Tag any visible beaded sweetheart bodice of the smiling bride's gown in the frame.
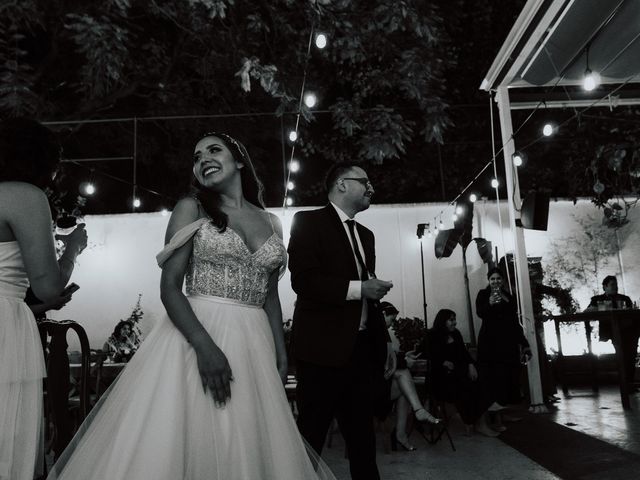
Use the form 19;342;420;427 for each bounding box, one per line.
186;222;286;306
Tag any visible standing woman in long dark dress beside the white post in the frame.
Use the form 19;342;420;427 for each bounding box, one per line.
476;268;531;416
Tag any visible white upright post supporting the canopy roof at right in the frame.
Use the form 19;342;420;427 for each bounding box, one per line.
496;86;547;413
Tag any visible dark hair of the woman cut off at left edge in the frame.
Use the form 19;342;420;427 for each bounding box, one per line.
0;117;61;188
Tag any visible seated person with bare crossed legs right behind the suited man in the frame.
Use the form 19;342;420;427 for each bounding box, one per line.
380;302;441;451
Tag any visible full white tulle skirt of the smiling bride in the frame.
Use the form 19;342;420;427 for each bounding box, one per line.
49;296;334;480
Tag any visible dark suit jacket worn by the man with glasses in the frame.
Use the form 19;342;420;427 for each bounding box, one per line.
288;205;387;367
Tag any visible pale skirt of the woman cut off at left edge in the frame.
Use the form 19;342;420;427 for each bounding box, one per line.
0;296;45;480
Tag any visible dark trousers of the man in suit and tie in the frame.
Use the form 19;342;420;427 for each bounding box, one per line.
296;332;382;480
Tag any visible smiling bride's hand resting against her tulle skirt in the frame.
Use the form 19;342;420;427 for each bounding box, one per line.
194;339;238;408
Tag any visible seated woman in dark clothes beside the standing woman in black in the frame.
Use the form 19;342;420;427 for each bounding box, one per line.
425;309;498;437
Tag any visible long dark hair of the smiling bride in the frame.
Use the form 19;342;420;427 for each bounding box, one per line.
191;132;265;232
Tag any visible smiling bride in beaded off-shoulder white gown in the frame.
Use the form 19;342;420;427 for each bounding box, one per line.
49;133;334;480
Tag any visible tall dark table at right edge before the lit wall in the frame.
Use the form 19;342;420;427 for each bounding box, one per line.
551;309;640;410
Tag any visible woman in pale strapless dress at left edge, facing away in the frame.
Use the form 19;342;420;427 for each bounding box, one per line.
0;118;87;480
